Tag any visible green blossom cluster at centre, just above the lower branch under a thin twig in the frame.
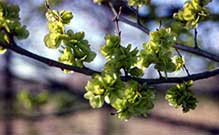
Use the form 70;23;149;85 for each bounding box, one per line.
100;35;143;77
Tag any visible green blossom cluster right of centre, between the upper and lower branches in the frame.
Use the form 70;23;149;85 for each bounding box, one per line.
140;28;184;77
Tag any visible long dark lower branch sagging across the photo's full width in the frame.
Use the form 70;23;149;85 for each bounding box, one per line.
0;42;219;84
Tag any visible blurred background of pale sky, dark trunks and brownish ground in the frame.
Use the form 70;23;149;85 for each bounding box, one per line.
0;0;219;135
